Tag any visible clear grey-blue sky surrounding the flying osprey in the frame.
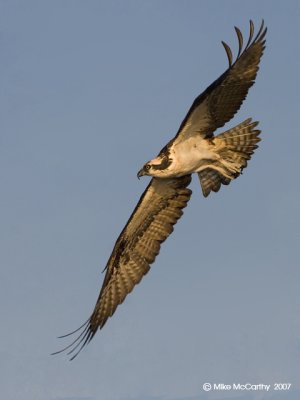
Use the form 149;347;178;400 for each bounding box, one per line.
0;0;300;400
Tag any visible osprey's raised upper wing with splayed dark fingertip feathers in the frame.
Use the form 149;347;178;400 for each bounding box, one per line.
174;21;267;144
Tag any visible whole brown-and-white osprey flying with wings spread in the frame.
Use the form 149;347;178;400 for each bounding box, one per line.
53;21;267;359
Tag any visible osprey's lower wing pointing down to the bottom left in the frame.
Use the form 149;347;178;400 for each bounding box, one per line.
57;175;192;359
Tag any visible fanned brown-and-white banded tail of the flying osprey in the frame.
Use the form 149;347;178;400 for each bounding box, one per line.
198;118;261;197
